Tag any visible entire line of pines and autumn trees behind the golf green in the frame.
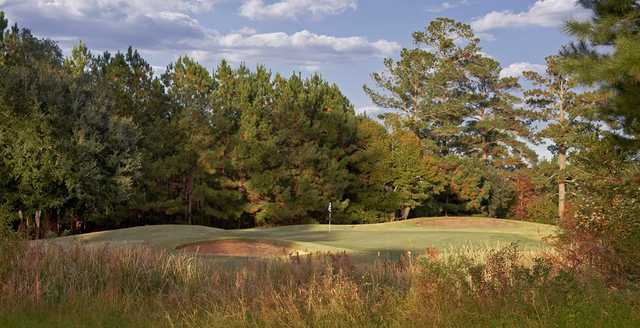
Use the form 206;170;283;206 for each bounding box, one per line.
0;0;640;270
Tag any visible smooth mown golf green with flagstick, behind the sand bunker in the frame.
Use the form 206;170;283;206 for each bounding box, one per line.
57;218;556;258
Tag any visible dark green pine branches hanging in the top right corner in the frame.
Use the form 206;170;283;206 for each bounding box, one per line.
562;0;640;136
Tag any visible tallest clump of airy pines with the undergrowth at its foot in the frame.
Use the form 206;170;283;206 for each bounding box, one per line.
364;18;537;217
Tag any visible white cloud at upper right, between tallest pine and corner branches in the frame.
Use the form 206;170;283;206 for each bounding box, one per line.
471;0;591;32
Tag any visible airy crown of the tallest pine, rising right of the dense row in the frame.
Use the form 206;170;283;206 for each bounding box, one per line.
364;18;479;155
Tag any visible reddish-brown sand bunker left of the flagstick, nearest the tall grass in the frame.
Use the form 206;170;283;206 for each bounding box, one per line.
177;240;299;257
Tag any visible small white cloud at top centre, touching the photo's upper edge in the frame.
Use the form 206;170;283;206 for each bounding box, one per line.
240;0;358;19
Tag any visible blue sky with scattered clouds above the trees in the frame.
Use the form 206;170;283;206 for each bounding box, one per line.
0;0;590;155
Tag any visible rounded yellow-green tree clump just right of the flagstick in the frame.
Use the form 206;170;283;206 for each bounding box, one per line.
353;115;445;222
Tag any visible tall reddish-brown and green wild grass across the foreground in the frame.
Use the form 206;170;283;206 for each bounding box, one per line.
0;238;640;327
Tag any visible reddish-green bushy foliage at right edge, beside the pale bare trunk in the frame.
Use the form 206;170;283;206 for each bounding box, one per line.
566;134;640;280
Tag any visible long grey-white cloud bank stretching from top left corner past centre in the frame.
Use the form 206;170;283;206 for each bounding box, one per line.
0;0;400;70
